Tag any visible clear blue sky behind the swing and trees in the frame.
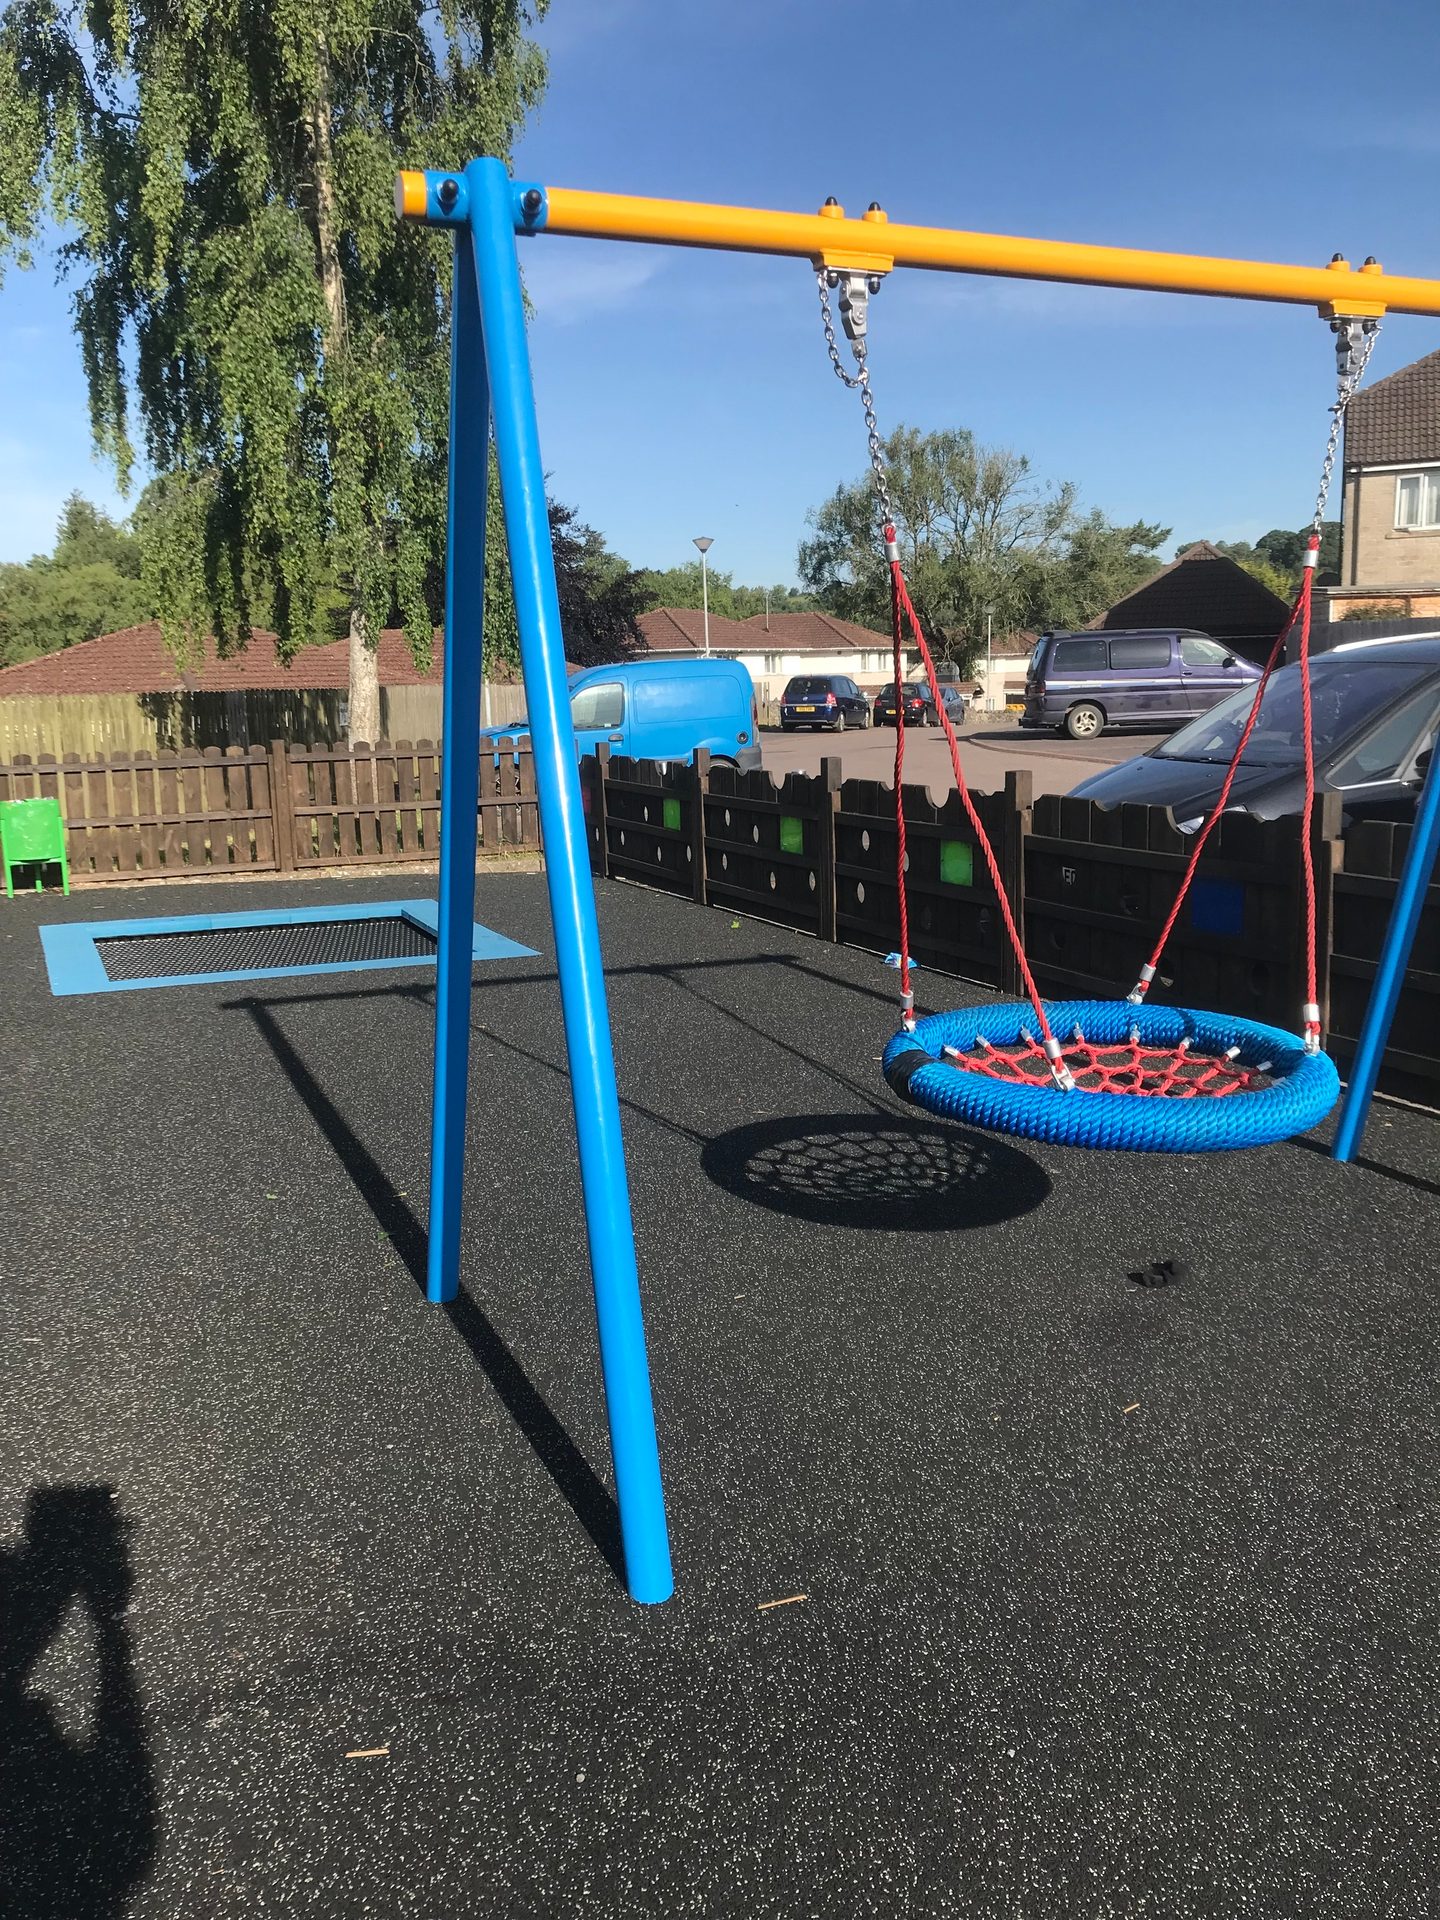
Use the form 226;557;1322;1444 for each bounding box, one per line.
0;0;1440;584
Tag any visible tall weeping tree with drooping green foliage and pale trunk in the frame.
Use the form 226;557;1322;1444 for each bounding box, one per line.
0;0;547;739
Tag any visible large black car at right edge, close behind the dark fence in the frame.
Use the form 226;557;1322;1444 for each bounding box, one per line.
1073;634;1440;828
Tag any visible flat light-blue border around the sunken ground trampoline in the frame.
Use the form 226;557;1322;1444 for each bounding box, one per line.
40;900;534;998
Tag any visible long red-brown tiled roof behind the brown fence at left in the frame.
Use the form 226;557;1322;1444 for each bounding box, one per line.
0;620;444;699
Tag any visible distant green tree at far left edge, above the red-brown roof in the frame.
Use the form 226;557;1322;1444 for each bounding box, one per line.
0;493;154;666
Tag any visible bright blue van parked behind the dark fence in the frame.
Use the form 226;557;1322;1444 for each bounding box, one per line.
522;659;760;774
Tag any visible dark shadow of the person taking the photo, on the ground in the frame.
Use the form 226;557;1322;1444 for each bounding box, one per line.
0;1486;157;1920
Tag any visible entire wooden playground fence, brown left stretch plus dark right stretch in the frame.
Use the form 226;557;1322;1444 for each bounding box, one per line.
0;737;1440;1106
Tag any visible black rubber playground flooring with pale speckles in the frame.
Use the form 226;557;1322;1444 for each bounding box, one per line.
0;876;1440;1920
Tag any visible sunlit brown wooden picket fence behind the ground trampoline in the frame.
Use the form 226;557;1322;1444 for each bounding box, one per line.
0;737;540;885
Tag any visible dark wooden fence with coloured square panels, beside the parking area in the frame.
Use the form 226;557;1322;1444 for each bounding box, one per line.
584;749;1440;1106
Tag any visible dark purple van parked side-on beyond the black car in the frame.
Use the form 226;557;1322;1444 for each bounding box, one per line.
1020;628;1260;739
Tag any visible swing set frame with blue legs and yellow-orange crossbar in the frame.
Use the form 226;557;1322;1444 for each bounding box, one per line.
396;159;1440;1603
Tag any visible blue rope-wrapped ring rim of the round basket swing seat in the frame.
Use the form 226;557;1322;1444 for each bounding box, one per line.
883;1000;1340;1154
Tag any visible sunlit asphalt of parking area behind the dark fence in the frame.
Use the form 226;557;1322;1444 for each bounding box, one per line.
760;714;1164;793
